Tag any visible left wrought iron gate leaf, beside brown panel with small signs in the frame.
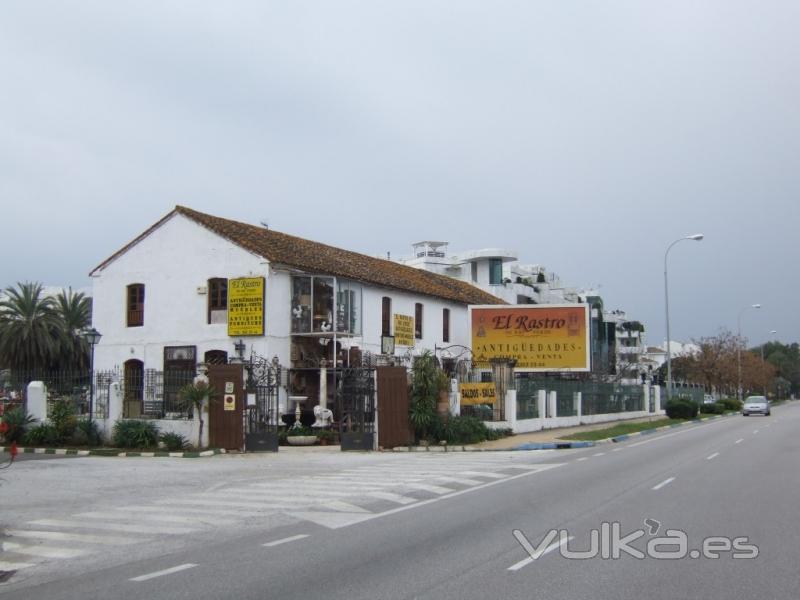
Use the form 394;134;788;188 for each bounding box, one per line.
244;354;281;452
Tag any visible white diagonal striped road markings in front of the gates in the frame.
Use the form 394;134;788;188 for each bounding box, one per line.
0;451;560;571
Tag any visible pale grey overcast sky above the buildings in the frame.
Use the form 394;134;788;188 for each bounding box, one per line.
0;0;800;344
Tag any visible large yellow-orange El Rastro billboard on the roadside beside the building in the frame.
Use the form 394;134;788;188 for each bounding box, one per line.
470;304;590;371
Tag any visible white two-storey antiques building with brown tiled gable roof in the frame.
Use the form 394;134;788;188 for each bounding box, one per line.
91;206;500;417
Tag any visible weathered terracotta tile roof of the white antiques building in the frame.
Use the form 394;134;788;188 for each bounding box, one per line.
92;206;505;304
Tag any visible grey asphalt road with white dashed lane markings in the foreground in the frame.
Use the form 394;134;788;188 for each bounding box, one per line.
0;405;800;600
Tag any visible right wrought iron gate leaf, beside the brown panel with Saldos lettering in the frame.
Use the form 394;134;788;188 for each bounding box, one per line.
336;367;375;450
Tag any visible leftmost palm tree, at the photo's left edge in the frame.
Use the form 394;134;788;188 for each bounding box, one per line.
0;282;60;372
